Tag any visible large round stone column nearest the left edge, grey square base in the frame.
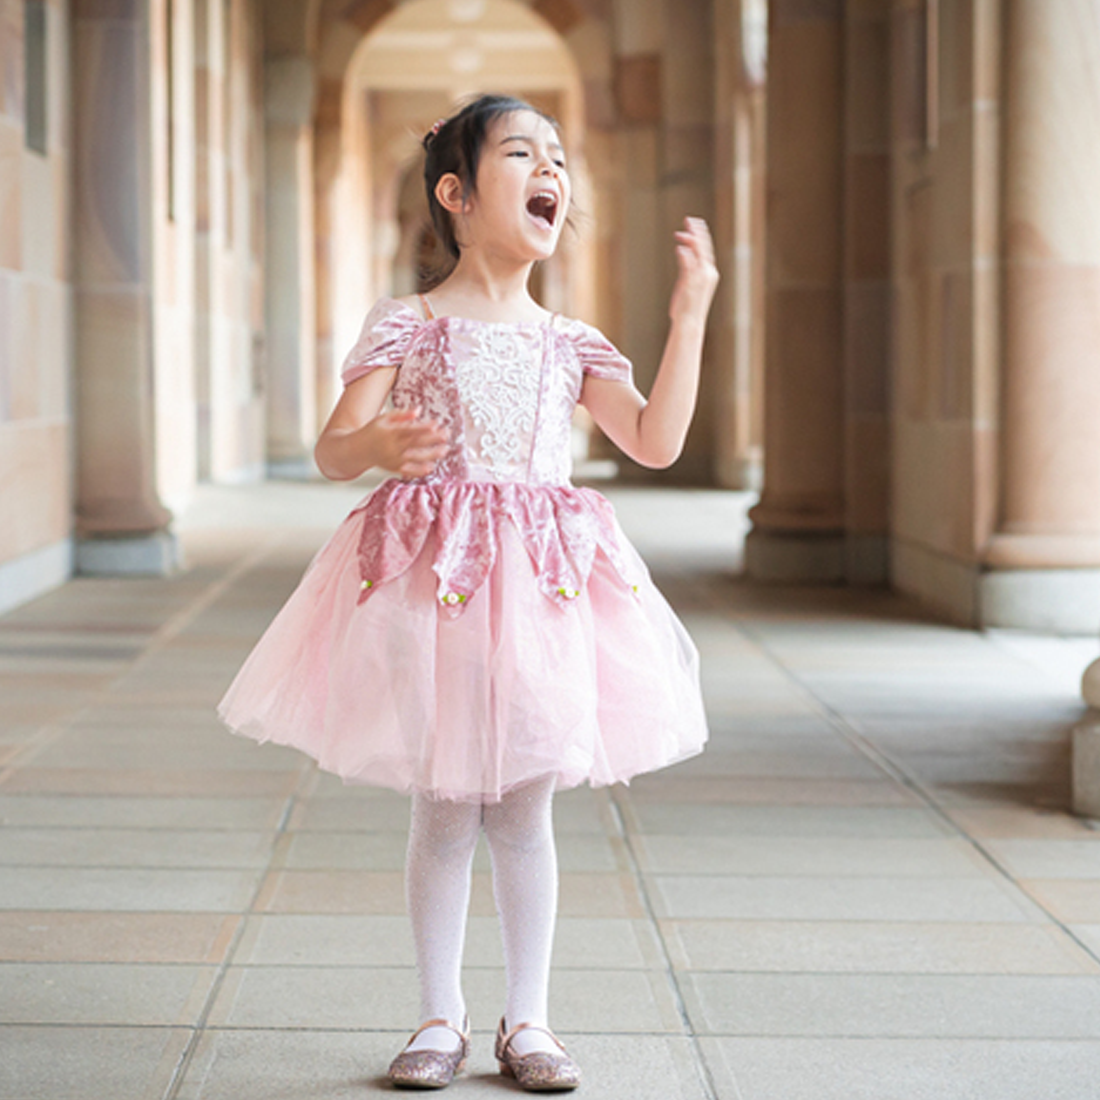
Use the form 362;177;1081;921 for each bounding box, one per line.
73;0;178;573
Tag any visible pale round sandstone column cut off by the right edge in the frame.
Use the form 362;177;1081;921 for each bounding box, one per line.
981;0;1100;633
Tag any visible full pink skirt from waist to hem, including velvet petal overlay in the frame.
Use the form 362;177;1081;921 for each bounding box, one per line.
219;481;706;801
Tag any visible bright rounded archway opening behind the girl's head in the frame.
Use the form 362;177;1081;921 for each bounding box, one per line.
318;0;594;398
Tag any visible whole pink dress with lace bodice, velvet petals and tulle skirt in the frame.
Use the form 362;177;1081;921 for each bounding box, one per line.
219;298;706;802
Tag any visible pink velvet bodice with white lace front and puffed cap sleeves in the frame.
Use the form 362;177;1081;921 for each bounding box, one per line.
343;299;630;485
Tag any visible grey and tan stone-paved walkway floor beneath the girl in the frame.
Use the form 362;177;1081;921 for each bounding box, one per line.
0;485;1100;1100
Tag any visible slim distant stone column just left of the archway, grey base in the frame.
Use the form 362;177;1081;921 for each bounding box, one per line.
264;55;317;476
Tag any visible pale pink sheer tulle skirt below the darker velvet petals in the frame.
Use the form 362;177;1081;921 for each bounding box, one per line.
219;484;706;802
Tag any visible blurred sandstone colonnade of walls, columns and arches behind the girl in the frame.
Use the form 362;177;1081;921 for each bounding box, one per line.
0;0;1100;634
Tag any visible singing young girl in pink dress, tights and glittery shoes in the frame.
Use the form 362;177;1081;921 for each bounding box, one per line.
220;96;718;1090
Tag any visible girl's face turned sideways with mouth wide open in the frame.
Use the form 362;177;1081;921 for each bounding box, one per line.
457;111;572;263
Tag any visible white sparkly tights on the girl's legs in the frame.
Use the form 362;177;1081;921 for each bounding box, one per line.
405;777;558;1054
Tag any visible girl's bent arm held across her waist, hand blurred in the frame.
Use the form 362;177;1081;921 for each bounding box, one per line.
314;366;447;481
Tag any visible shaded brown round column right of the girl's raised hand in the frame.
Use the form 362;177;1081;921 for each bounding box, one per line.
746;0;845;581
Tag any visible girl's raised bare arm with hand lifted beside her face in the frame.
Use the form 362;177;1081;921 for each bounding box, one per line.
581;218;718;468
